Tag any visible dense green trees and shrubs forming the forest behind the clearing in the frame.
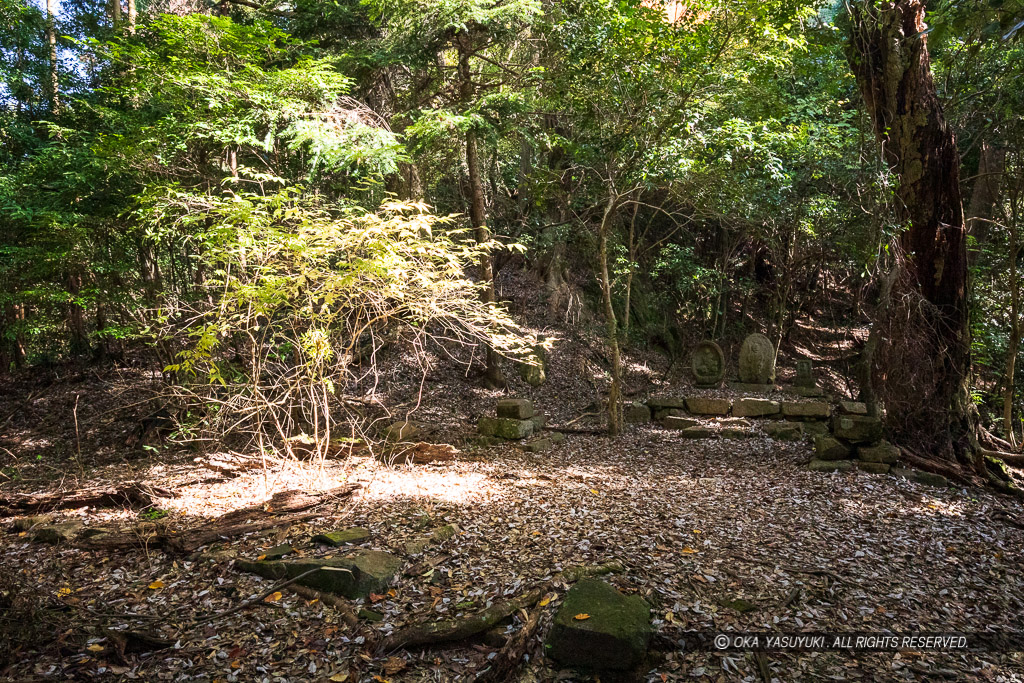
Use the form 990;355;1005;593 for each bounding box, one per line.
0;0;1024;479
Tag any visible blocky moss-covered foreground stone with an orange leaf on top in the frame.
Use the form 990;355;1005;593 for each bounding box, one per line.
544;579;651;671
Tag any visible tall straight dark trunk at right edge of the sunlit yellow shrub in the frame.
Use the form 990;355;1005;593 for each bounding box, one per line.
459;37;505;386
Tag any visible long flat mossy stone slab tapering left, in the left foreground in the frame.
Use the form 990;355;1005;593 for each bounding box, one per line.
236;550;404;599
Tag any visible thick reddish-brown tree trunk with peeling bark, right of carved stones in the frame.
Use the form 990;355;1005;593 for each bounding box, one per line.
849;0;984;467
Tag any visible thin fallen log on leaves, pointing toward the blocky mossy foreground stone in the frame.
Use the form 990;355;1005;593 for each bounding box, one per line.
380;562;623;652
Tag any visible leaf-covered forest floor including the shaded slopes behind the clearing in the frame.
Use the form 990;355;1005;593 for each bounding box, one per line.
0;317;1024;683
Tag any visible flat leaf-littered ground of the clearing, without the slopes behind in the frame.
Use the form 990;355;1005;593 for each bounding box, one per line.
0;426;1024;681
